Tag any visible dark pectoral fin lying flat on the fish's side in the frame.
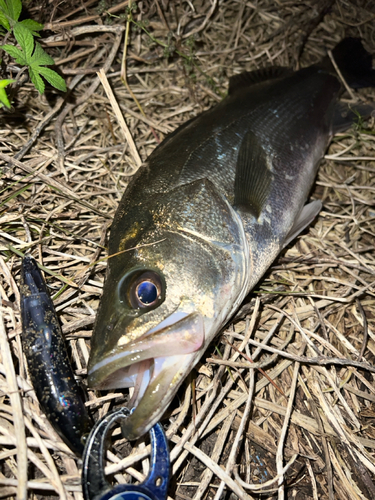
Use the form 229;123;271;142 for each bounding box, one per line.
234;130;272;218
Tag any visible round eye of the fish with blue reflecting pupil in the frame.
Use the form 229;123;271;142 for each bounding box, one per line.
127;271;163;309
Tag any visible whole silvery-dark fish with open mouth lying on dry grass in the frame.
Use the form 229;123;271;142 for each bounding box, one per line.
88;38;375;439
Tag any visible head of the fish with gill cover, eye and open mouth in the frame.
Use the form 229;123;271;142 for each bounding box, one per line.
88;179;249;439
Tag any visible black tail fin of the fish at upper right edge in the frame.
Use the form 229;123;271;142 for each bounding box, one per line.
323;37;375;89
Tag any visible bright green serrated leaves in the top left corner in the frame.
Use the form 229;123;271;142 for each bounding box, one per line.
0;0;66;107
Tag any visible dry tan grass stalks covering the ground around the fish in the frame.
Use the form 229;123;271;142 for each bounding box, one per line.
0;0;375;500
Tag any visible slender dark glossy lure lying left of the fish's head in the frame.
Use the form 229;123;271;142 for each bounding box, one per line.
20;256;93;456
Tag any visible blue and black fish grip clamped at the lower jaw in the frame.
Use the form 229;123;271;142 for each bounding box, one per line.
82;408;170;500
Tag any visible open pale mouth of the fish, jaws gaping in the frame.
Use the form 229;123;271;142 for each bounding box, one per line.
88;311;205;439
